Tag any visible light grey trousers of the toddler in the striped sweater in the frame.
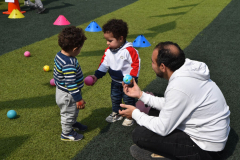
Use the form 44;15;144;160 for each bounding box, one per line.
56;88;79;134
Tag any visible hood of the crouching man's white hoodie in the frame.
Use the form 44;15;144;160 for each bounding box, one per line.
169;58;210;82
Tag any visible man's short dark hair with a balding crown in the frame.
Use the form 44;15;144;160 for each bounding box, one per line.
155;41;185;72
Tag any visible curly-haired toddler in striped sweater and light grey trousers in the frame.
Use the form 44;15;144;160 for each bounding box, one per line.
53;26;87;141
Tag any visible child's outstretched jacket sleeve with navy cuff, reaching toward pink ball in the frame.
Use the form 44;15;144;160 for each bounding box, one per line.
94;49;109;79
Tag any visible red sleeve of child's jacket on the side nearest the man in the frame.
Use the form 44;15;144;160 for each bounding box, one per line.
126;47;140;77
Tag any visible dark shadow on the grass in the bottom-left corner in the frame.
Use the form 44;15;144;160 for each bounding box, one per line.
0;135;30;159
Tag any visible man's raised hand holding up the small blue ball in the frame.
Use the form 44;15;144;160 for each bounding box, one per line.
122;78;142;99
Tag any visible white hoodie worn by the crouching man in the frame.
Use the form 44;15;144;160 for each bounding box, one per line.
132;59;230;151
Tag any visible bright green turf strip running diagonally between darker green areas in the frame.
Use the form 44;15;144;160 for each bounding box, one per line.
0;0;236;159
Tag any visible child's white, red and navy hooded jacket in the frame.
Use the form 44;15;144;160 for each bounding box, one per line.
94;42;141;83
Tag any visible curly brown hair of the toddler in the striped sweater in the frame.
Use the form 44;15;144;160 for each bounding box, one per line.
58;26;87;52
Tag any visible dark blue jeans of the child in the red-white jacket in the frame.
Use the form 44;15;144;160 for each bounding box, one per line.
111;79;137;113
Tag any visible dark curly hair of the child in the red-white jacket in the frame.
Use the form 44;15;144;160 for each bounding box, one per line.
102;19;128;40
